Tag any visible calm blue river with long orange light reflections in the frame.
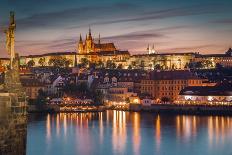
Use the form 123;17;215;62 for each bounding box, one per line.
27;111;232;155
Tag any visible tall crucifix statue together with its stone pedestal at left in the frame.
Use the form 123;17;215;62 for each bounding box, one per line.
0;12;27;155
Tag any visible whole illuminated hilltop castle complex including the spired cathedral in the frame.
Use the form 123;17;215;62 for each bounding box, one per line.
0;28;232;69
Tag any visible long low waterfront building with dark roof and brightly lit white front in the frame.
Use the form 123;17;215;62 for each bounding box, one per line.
175;82;232;105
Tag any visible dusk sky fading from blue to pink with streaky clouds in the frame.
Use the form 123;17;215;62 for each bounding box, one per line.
0;0;232;56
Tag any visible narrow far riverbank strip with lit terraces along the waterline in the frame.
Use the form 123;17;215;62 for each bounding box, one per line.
28;104;232;115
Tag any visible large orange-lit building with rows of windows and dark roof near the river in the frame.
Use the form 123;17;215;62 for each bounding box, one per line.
141;70;206;102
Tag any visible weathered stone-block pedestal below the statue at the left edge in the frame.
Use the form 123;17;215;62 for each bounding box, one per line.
0;92;27;155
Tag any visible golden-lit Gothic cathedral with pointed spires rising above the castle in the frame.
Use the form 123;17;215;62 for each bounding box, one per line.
77;29;117;54
